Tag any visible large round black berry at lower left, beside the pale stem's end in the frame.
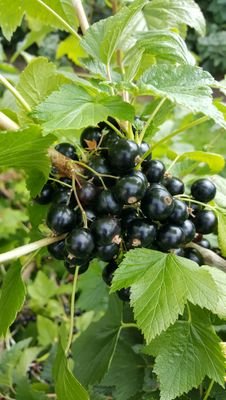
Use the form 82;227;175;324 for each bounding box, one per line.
65;228;95;260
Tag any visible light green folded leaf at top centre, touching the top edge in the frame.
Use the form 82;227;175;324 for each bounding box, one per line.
81;0;147;64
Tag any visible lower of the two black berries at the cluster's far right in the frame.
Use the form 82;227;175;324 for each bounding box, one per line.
194;210;217;235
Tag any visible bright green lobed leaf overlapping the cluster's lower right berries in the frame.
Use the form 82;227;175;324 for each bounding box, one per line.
111;249;217;342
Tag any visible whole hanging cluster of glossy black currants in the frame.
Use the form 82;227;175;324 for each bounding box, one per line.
36;123;217;300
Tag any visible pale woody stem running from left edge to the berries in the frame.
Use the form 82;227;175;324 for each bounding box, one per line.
0;234;66;263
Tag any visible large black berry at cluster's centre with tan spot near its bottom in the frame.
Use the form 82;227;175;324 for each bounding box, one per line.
114;174;148;204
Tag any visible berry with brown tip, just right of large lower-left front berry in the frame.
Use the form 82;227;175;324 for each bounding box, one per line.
91;217;121;245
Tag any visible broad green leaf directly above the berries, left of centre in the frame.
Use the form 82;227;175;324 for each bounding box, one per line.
33;85;134;130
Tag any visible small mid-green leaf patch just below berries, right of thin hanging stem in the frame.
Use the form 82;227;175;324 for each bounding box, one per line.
76;259;109;311
